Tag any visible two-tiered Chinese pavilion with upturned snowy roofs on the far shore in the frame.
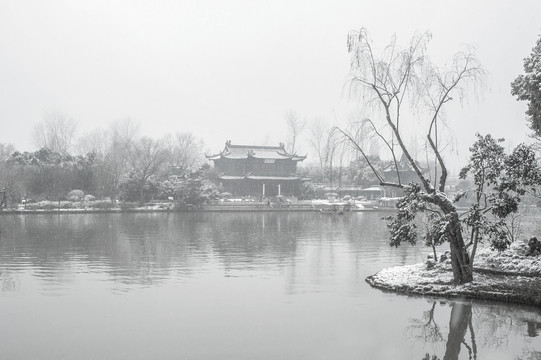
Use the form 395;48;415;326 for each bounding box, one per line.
207;141;306;196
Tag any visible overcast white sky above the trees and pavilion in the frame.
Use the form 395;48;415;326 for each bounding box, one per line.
0;0;541;169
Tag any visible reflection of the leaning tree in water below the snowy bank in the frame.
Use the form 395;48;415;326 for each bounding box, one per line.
406;300;541;360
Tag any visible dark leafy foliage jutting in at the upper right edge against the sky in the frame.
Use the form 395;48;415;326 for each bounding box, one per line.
511;37;541;137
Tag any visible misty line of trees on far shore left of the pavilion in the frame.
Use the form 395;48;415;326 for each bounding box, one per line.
0;118;217;205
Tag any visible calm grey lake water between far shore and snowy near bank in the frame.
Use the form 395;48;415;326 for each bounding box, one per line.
0;212;541;360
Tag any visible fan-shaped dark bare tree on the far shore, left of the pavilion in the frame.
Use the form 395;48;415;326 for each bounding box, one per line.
128;137;167;202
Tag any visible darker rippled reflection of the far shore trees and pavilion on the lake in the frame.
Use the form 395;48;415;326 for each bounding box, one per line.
0;213;396;291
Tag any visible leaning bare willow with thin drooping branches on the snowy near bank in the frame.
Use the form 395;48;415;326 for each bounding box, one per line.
335;28;485;283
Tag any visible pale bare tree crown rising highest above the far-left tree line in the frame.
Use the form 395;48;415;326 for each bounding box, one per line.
33;111;77;154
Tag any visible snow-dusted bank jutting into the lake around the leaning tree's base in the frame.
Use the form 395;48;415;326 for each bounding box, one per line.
366;240;541;306
